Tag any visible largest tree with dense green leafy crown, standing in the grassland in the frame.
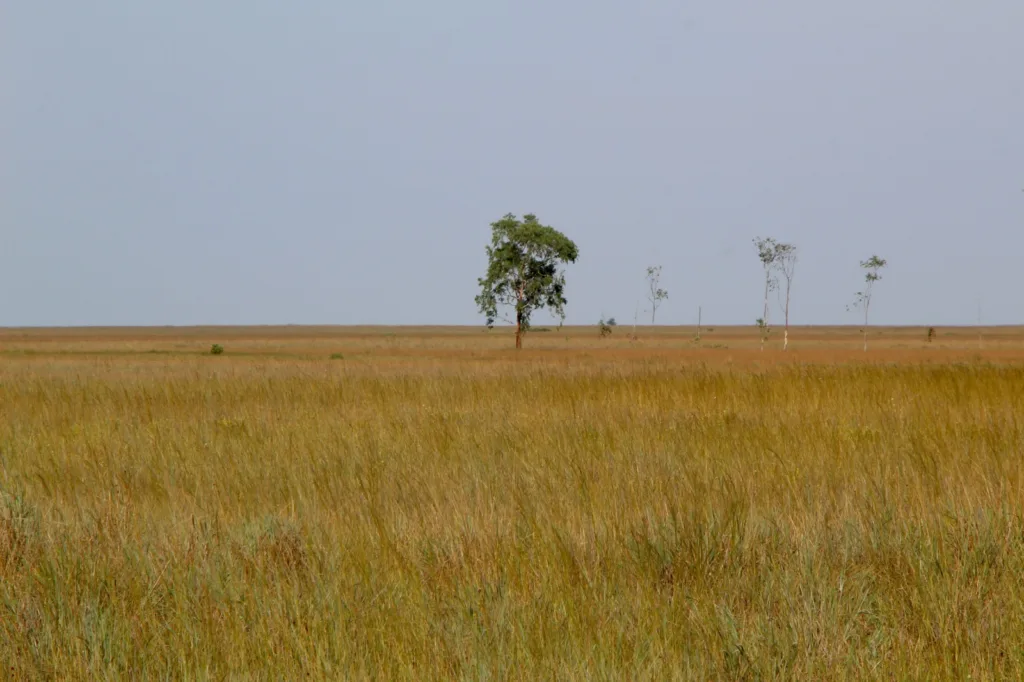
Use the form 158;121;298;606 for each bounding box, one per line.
476;213;579;348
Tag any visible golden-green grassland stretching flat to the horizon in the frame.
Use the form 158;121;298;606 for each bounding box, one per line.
0;327;1024;680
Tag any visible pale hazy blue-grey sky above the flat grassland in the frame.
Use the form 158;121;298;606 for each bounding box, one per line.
0;0;1024;326
